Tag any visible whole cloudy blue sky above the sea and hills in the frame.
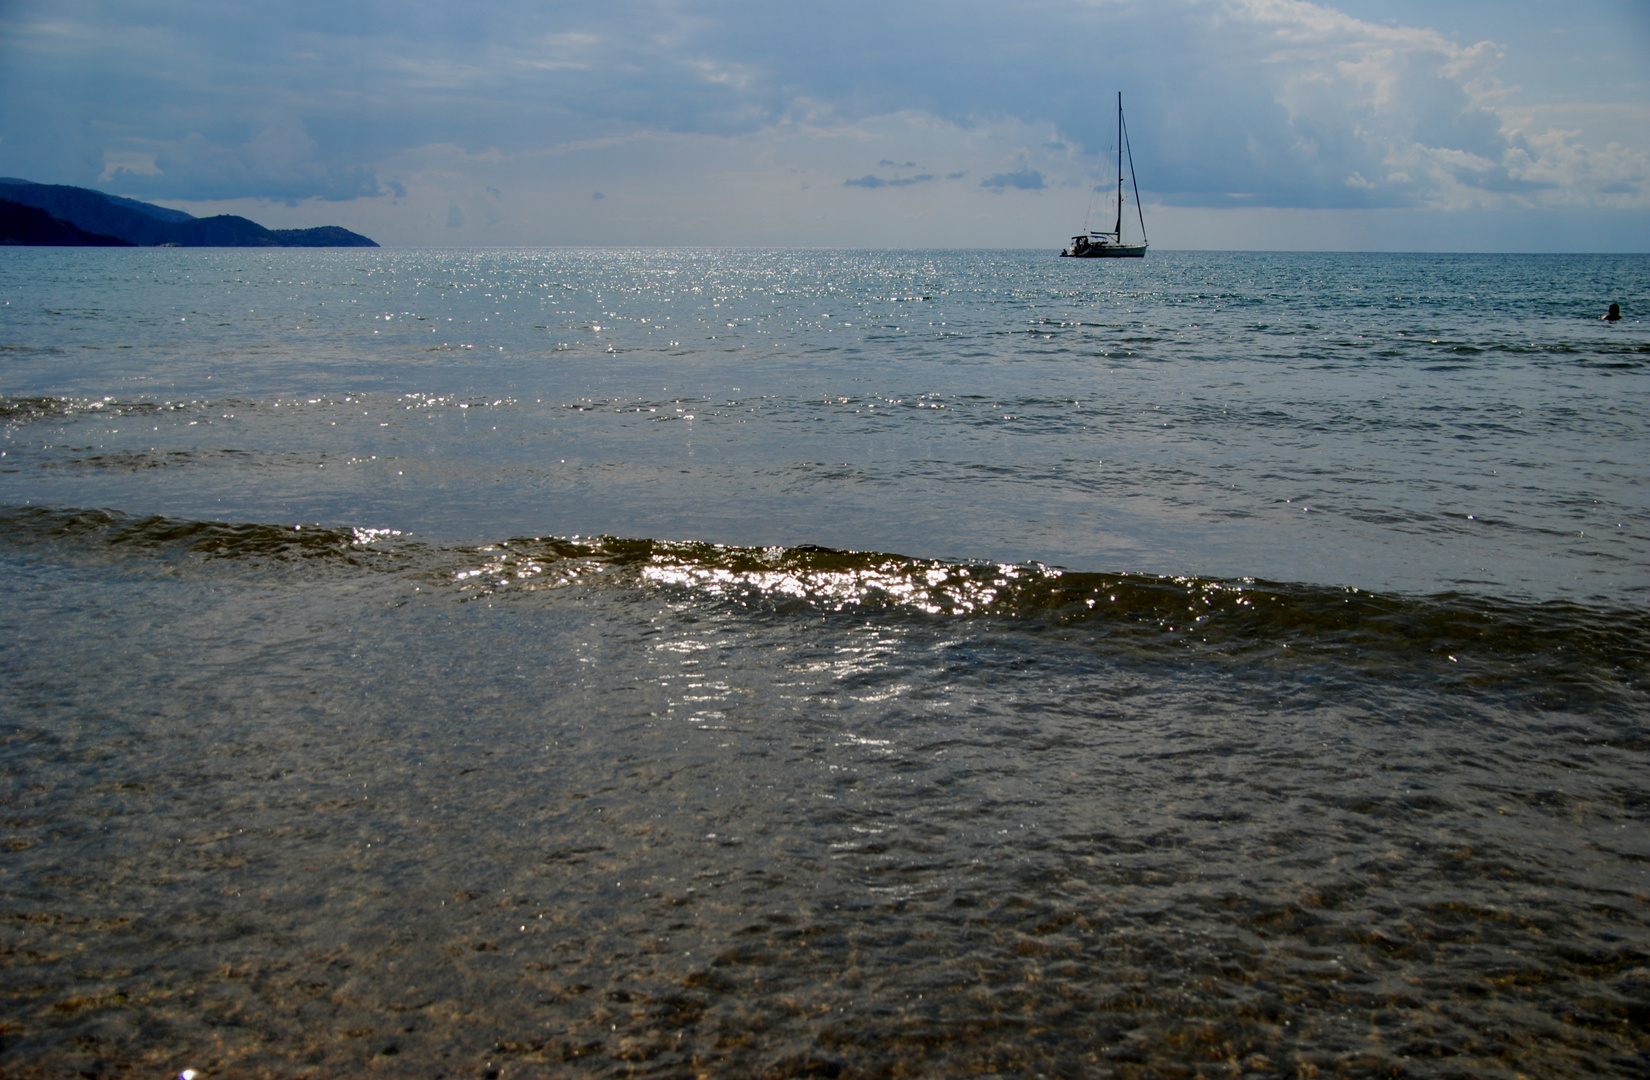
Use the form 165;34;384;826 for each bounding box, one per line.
0;0;1650;252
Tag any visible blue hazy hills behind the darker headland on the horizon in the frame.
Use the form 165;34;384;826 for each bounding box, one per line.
0;176;378;247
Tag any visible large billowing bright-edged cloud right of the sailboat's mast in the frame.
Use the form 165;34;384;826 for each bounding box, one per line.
1137;0;1650;209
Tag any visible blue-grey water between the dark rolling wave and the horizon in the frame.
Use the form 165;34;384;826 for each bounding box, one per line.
0;249;1650;602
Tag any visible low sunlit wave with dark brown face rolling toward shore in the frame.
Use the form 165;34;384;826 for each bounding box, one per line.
0;506;1650;697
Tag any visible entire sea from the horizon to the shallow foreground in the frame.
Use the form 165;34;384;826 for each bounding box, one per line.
0;247;1650;1080
